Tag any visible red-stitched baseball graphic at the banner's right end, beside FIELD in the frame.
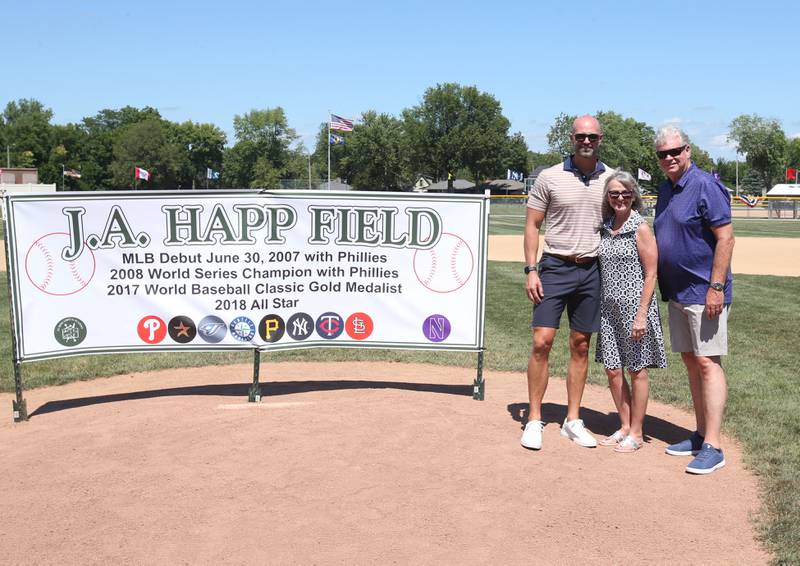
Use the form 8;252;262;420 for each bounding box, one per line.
414;232;475;293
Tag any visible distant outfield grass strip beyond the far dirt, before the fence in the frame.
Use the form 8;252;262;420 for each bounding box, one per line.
489;201;800;238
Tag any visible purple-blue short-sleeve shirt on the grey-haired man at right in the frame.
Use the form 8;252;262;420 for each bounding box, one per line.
653;163;733;305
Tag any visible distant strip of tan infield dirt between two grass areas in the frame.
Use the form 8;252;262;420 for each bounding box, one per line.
489;235;800;277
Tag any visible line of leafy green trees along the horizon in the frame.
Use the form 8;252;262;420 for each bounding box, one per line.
0;83;800;194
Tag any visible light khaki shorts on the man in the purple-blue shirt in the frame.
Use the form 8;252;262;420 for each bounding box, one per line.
669;301;731;357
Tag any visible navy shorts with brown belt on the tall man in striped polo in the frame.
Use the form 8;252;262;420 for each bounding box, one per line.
533;254;600;332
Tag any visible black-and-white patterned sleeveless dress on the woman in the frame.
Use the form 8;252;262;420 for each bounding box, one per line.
595;210;667;371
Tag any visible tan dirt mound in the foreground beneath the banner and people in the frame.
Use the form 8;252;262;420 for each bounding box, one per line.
0;363;768;564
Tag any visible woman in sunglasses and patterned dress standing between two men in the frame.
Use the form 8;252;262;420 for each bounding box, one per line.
595;171;667;452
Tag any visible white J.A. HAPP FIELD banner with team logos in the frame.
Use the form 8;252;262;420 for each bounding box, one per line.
5;191;488;360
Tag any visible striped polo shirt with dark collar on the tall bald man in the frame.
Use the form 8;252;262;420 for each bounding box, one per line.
528;157;614;257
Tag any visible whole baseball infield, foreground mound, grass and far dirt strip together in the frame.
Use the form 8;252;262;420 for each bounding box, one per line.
0;215;800;564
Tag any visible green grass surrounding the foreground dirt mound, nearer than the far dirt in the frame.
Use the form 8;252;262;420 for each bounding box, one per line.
0;262;800;564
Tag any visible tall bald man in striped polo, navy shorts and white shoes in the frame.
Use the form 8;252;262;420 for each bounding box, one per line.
521;116;613;450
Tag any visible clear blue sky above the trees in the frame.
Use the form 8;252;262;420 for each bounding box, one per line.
0;0;800;159
